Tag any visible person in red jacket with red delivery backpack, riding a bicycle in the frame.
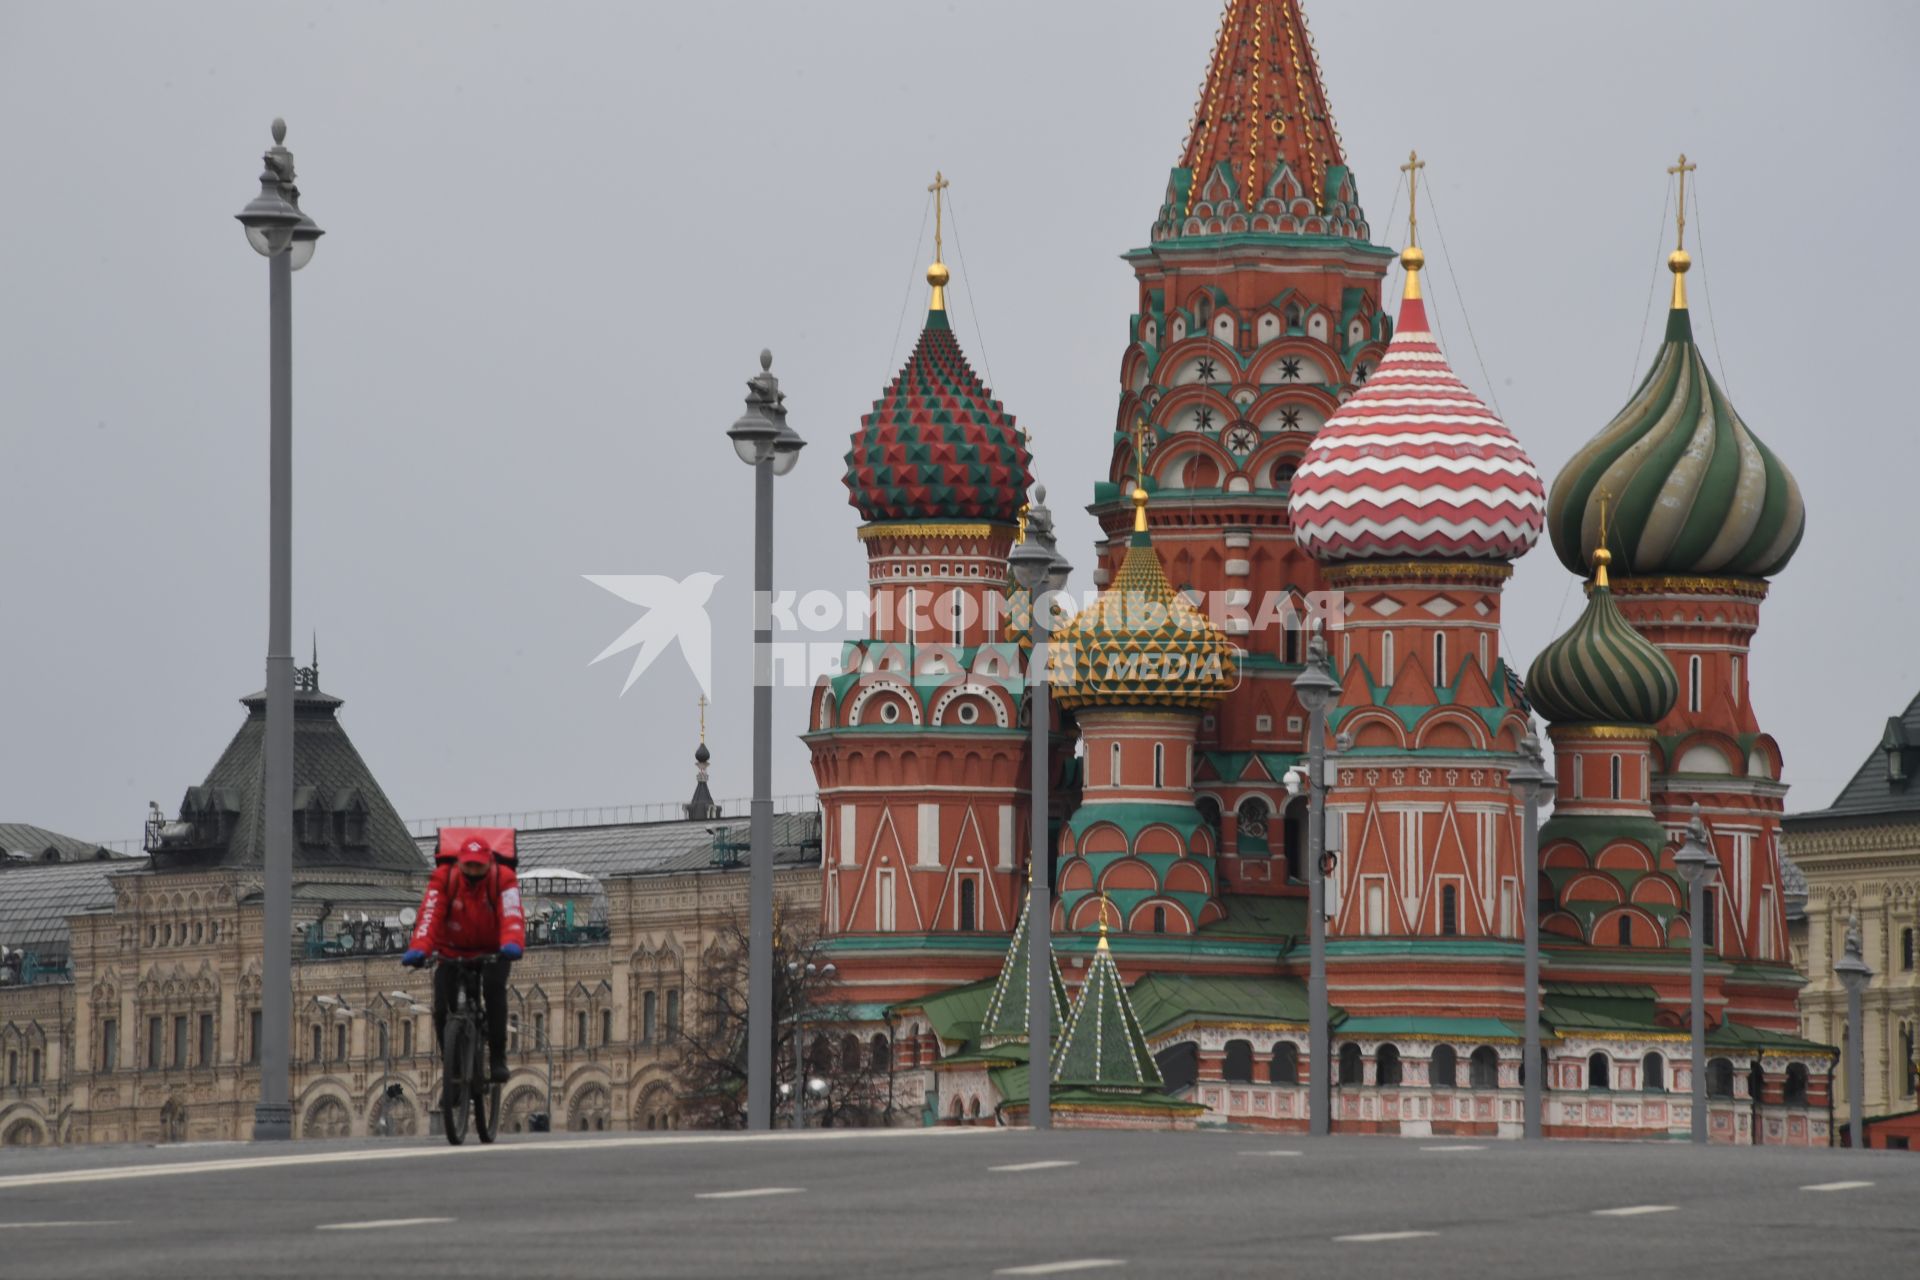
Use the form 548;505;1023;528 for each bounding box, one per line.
399;837;526;1082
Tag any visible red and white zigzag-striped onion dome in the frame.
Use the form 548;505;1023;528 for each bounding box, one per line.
1286;297;1546;560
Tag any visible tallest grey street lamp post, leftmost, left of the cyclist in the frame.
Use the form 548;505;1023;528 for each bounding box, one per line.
236;119;324;1142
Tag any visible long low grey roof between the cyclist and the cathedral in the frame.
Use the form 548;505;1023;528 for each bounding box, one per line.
420;810;820;881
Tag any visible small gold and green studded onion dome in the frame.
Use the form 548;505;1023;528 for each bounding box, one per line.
1048;489;1240;710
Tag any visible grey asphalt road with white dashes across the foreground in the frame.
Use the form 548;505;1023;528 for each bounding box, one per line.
0;1130;1920;1280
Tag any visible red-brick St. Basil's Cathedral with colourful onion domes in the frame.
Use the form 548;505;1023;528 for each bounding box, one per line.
804;0;1836;1146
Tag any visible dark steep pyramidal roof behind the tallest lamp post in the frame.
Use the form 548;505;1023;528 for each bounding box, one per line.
154;689;426;871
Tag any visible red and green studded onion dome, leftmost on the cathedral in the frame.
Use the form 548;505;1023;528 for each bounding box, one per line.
847;278;1031;524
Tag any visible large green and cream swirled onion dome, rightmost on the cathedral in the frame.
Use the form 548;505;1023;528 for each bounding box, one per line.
1548;251;1807;578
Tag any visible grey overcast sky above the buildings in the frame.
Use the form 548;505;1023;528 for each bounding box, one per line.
0;0;1920;852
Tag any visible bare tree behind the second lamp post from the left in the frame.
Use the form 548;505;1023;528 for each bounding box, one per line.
668;902;891;1128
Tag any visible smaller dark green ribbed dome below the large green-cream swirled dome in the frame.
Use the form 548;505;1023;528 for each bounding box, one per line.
1526;549;1680;727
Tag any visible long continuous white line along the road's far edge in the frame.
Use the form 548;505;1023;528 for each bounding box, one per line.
0;1125;1010;1192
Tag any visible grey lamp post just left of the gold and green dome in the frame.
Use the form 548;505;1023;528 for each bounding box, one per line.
1006;486;1071;1128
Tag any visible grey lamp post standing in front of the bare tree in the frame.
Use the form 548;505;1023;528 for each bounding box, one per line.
728;351;806;1130
